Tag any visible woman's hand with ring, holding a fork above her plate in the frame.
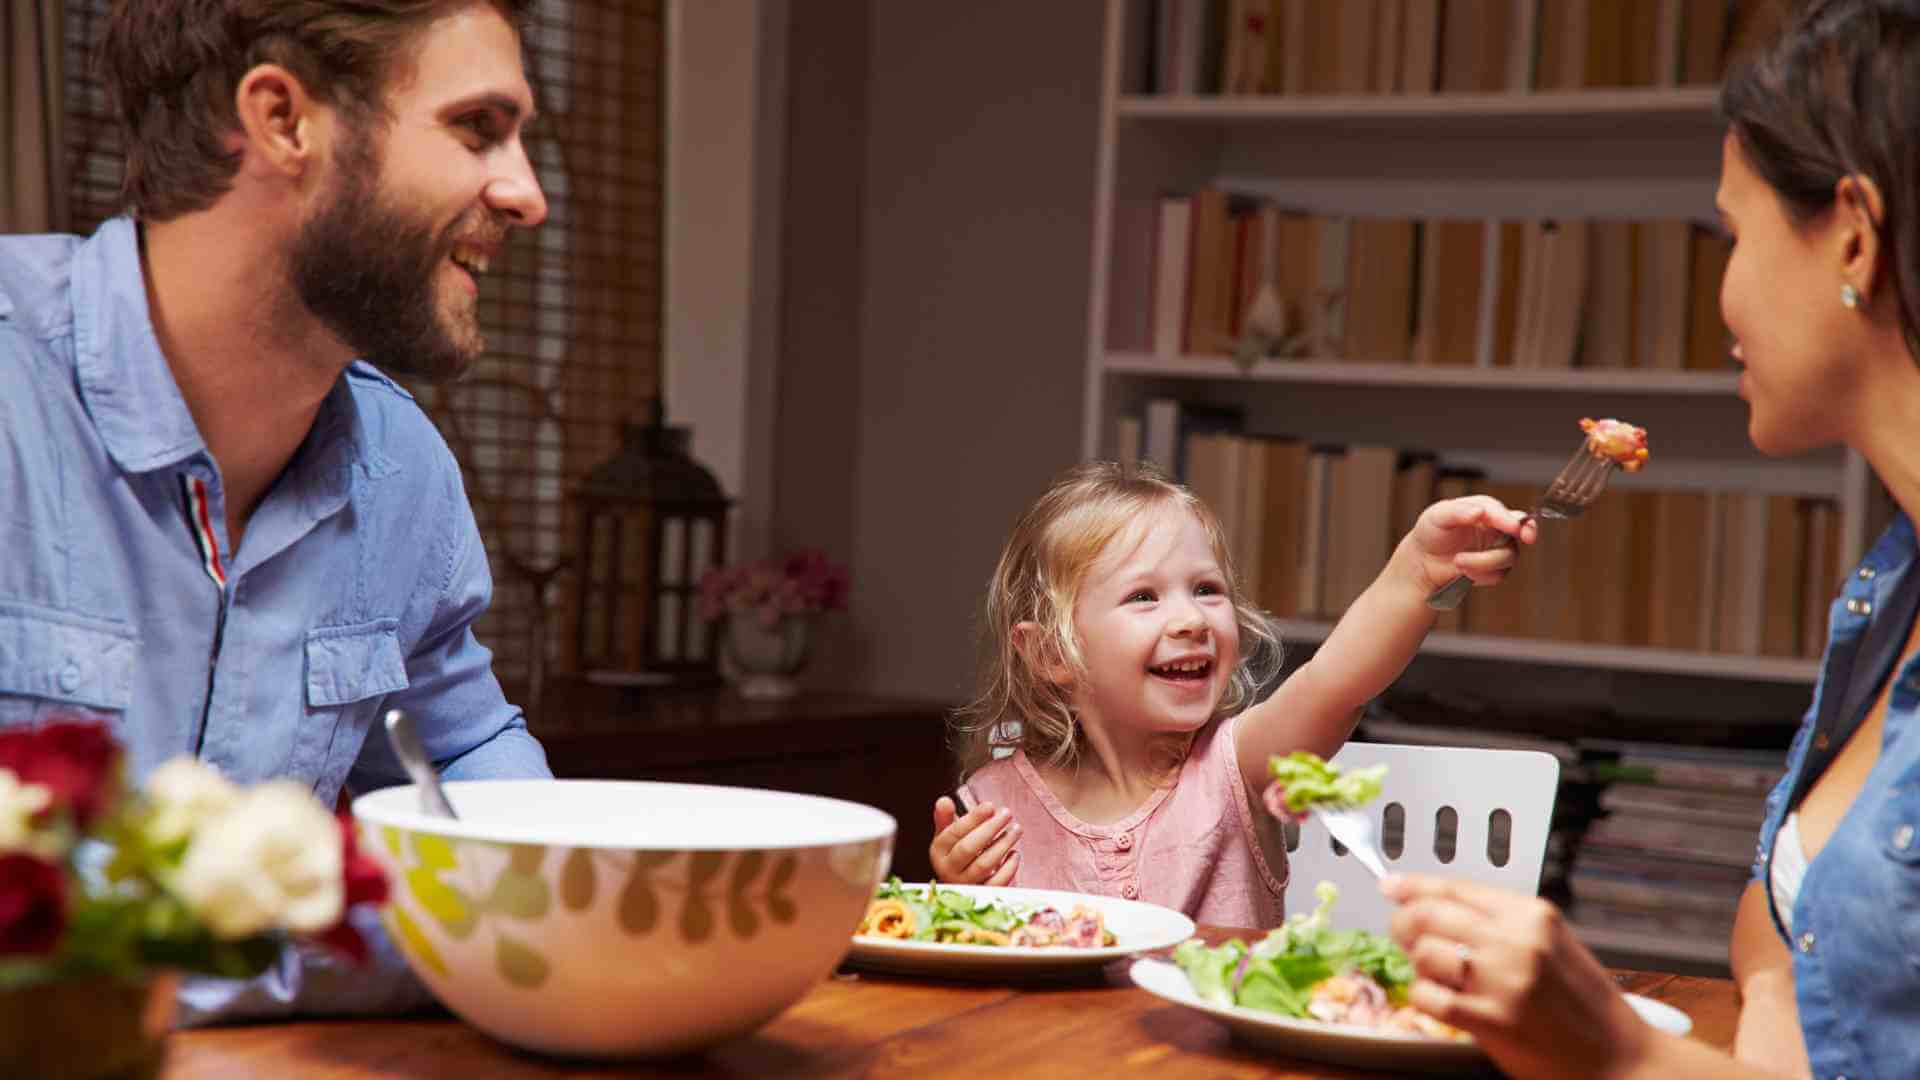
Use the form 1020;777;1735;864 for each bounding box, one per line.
1380;874;1659;1076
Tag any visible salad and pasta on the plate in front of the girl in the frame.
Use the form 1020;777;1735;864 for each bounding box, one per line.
854;876;1114;949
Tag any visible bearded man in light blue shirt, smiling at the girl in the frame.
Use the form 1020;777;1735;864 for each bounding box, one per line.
0;0;549;1022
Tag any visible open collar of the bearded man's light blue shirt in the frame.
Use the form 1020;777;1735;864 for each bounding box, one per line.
73;217;392;495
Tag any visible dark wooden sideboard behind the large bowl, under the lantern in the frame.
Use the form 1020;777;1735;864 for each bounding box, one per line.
528;678;954;880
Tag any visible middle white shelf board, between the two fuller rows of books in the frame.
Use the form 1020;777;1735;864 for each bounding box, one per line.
1102;352;1740;398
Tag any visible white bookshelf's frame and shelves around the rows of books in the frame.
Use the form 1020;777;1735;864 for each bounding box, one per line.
1081;0;1868;688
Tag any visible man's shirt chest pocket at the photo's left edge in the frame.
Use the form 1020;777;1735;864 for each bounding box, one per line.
0;603;138;734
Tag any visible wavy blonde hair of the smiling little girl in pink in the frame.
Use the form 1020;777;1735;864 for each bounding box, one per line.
952;461;1281;776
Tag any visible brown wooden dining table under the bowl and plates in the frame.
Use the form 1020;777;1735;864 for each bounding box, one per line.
161;926;1738;1080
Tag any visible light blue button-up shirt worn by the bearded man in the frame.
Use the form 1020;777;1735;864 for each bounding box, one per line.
0;219;549;1022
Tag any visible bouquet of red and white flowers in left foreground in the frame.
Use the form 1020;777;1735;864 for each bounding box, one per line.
0;721;386;1074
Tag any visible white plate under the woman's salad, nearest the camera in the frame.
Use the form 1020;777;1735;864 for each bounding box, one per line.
1127;959;1693;1074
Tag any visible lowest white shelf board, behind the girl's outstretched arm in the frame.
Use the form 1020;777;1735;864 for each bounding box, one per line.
1281;619;1820;686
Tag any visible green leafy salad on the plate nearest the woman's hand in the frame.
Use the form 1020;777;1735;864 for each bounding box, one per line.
1173;882;1413;1019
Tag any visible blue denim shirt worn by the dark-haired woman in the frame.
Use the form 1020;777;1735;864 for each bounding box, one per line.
1753;515;1920;1080
